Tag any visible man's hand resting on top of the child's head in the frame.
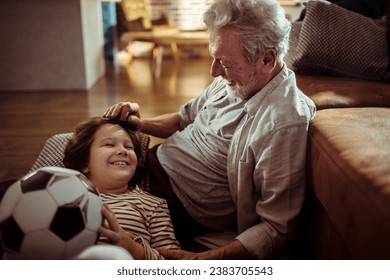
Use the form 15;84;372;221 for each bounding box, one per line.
103;102;141;129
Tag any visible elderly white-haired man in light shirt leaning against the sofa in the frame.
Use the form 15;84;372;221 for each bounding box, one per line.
104;0;315;259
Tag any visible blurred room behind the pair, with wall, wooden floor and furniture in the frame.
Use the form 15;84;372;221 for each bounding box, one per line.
0;0;302;181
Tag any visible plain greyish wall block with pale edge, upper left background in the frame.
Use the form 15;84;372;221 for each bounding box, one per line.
0;0;104;91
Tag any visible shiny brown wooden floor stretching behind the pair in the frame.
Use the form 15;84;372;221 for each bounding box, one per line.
0;58;212;181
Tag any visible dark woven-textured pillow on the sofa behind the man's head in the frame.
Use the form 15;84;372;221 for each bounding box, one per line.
289;1;388;80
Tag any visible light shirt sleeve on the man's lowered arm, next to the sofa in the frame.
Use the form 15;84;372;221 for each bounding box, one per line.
236;123;307;259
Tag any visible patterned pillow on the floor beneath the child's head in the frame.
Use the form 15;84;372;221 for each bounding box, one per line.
29;132;150;190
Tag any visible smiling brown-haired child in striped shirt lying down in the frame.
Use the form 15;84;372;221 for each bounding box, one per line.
63;117;180;259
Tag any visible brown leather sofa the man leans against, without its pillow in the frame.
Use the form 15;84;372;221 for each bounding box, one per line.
290;74;390;259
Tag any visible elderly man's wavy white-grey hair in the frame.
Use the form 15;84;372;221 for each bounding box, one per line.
203;0;291;63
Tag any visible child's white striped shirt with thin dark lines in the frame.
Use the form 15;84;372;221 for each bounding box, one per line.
99;187;180;260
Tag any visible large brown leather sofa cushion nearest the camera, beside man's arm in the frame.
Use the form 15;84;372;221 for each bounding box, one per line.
308;108;390;259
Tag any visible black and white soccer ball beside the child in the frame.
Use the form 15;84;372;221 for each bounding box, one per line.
0;167;103;260
